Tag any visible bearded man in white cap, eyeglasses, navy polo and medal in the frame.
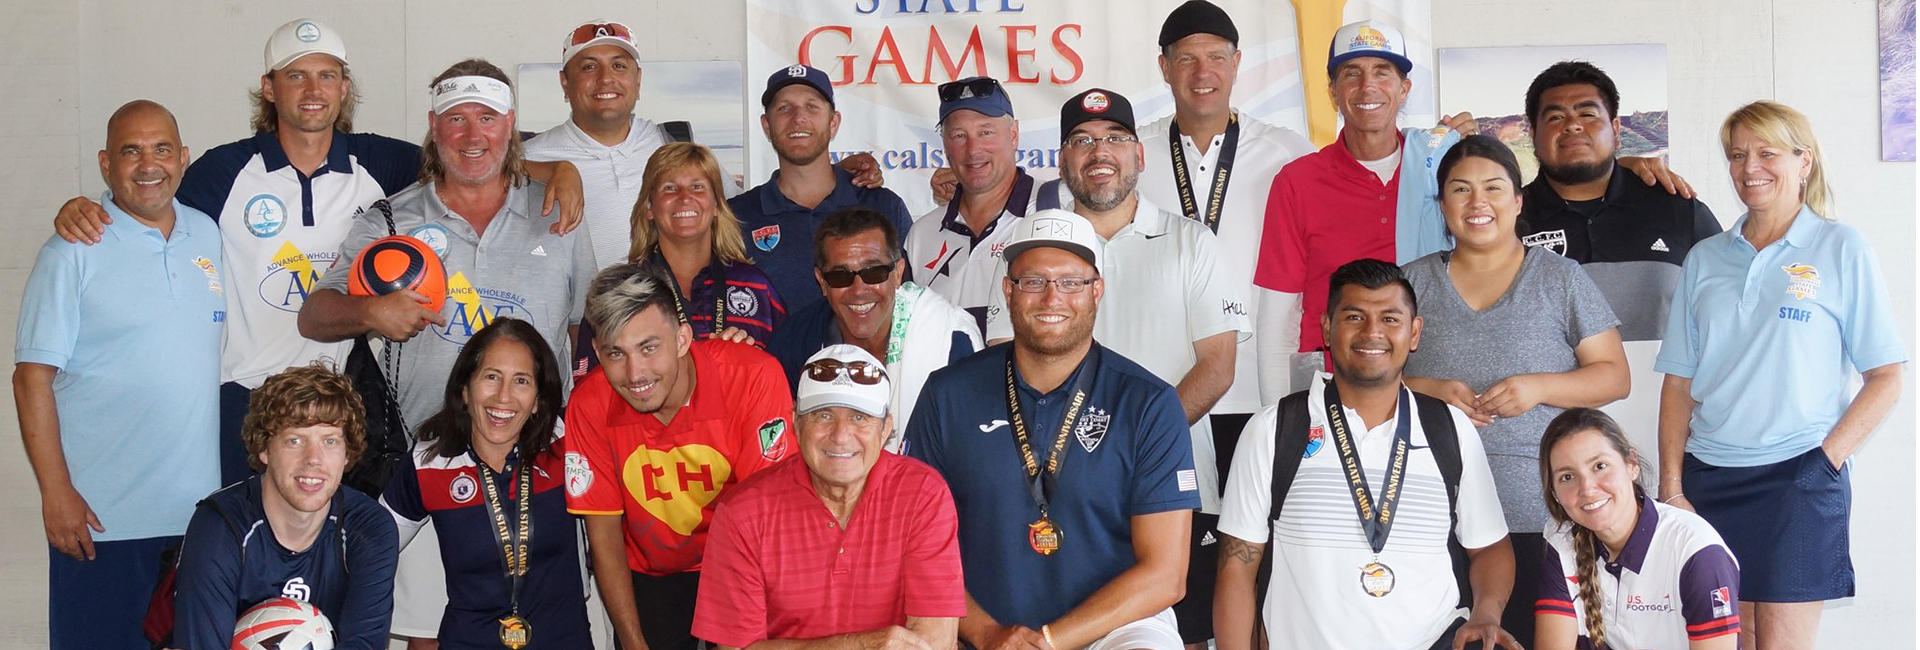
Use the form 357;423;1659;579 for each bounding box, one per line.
906;211;1200;650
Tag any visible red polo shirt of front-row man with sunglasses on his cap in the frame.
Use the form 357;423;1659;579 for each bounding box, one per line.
693;453;966;648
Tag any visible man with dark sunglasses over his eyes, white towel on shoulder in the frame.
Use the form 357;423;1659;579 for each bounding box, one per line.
766;207;981;451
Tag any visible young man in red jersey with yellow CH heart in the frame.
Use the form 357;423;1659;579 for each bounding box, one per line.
566;265;793;650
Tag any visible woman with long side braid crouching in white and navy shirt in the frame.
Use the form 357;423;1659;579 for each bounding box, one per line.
1532;408;1740;650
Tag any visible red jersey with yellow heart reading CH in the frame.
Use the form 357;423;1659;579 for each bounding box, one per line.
566;341;793;575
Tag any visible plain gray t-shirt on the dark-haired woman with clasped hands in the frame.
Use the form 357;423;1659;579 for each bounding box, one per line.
1405;247;1620;533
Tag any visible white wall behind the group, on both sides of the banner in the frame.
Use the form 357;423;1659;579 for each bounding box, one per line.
0;0;1920;648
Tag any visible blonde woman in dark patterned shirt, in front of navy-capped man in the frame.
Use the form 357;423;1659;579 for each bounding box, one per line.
628;142;787;347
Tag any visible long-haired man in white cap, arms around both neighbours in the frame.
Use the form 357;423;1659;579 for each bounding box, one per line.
54;17;580;491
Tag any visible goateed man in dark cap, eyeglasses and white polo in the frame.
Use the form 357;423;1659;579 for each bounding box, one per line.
987;88;1252;636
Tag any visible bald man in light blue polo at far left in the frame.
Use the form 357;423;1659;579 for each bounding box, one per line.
13;100;227;648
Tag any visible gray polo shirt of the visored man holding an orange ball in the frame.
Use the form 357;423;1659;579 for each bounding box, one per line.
317;180;599;433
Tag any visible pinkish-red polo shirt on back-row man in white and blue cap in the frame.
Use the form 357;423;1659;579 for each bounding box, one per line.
1254;130;1405;353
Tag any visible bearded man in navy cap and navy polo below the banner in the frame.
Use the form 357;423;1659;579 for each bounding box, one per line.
728;65;914;313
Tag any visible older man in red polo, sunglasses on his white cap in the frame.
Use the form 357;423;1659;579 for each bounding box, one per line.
693;343;966;650
